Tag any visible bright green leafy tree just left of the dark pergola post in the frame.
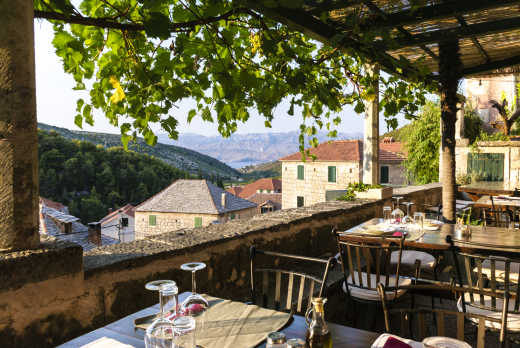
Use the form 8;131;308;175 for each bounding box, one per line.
404;101;441;184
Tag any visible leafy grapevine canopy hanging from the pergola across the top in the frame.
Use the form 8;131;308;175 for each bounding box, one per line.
35;0;426;151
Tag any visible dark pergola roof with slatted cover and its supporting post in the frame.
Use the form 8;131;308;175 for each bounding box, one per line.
247;0;520;222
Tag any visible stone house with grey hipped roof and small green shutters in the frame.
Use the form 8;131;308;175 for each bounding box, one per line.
135;180;256;239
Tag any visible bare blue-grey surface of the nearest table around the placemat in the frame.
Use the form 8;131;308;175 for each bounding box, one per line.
58;292;380;348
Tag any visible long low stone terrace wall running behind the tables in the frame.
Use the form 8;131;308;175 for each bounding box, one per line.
0;185;441;347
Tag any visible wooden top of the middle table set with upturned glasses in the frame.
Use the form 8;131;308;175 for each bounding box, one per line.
339;218;520;258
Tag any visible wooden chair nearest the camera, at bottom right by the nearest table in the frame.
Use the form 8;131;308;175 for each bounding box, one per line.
378;284;509;348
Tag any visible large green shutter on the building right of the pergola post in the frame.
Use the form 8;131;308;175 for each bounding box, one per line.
468;153;504;181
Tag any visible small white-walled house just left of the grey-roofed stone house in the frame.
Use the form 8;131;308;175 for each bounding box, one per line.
99;204;135;243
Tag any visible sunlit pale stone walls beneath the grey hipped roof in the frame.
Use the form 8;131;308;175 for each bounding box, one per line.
135;207;257;239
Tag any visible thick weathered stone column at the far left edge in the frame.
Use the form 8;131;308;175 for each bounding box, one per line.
0;0;40;251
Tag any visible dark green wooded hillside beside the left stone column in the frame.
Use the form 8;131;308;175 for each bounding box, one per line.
38;130;187;223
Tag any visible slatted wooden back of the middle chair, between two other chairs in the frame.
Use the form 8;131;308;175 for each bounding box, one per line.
336;233;404;297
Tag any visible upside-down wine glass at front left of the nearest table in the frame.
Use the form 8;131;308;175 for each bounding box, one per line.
144;282;179;348
